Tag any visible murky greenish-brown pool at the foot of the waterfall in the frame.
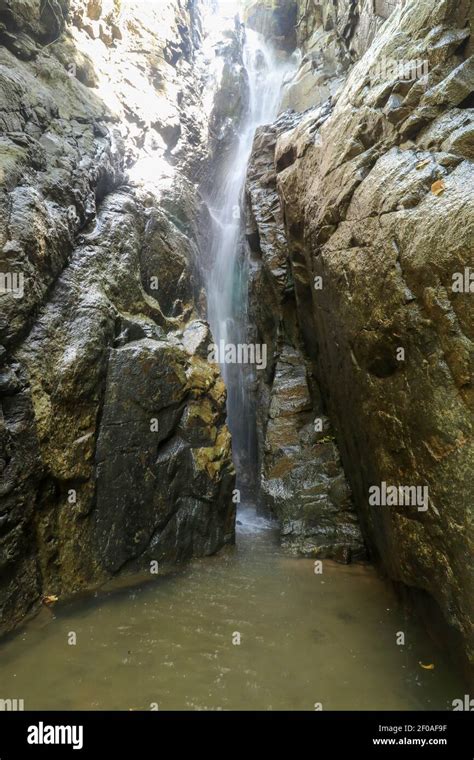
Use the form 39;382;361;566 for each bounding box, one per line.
0;510;464;710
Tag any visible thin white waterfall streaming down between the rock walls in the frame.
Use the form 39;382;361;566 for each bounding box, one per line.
207;22;294;490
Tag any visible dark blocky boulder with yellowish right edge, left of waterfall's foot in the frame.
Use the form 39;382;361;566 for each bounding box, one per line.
94;338;234;572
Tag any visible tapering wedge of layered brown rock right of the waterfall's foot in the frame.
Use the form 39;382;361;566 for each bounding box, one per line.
261;345;366;562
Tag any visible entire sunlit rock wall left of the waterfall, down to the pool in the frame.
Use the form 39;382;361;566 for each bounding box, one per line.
0;0;235;632
